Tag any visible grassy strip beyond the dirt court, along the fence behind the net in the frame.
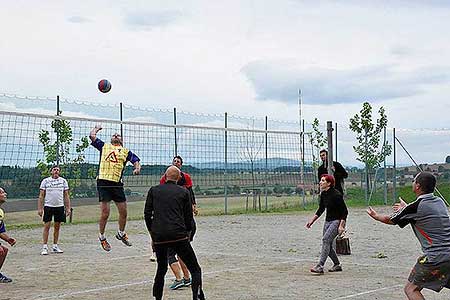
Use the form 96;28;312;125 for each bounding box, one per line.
6;183;450;230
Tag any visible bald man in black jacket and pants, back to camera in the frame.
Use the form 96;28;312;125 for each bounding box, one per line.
144;166;205;300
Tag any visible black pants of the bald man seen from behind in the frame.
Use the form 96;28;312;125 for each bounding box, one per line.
153;239;205;300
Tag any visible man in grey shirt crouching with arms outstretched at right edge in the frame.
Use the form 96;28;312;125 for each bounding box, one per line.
367;172;450;300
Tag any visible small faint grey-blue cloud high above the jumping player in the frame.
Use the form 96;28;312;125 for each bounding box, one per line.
124;10;181;30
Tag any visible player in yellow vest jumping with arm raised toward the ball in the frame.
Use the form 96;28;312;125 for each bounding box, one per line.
89;125;141;251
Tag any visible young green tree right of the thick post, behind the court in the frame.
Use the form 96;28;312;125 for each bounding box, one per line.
349;102;392;200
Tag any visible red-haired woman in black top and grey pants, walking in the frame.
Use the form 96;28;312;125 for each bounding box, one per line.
306;175;348;274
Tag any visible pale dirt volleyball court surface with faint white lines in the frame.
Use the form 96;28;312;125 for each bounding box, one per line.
0;207;450;300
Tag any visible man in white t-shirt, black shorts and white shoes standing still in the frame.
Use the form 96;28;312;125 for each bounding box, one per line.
38;166;70;255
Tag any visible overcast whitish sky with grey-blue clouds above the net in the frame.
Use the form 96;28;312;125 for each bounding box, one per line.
0;0;450;165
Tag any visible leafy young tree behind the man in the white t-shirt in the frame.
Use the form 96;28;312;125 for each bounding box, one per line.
37;118;95;197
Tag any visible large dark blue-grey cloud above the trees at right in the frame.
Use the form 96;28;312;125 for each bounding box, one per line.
241;60;450;104
